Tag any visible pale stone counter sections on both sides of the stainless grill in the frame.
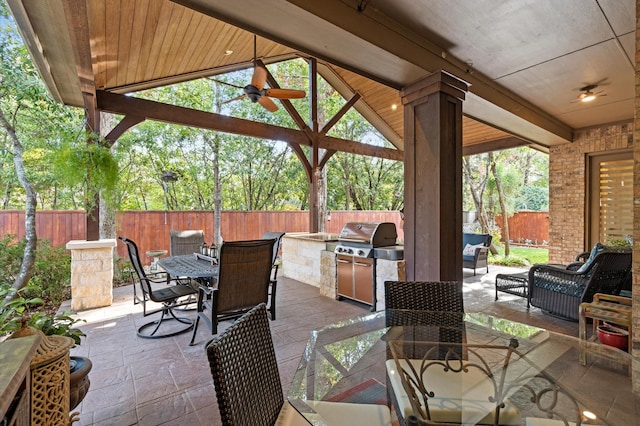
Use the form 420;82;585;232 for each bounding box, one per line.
282;232;406;311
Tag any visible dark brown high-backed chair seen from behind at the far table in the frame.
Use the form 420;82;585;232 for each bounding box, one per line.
189;240;275;345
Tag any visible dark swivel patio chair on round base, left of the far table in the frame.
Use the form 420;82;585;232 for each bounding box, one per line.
119;237;196;338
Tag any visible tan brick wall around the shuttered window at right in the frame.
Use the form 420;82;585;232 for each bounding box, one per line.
549;123;633;263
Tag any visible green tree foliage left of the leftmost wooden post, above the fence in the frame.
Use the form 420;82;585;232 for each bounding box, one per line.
0;7;84;209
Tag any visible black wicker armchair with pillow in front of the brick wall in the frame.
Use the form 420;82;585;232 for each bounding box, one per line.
527;251;631;321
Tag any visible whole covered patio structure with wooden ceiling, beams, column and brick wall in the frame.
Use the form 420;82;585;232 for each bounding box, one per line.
8;0;640;389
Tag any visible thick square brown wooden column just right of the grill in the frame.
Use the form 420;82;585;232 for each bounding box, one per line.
401;71;468;281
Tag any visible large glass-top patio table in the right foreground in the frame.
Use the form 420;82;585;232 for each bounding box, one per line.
287;311;640;426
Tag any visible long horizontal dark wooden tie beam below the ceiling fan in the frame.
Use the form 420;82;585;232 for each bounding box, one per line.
97;90;403;161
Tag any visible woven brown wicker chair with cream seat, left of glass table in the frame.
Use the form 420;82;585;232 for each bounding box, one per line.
206;303;391;426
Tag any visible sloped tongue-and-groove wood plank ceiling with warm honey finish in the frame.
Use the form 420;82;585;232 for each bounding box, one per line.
9;0;528;152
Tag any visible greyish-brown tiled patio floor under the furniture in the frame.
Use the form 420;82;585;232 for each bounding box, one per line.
63;266;578;426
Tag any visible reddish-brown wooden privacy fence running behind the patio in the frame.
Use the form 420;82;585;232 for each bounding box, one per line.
0;210;549;261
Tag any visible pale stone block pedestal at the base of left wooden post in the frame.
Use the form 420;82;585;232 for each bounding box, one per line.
67;239;116;311
